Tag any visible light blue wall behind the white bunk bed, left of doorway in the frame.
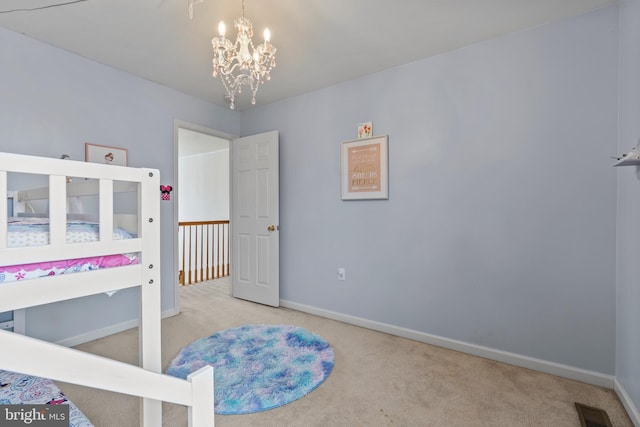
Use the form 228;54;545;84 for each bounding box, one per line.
0;28;240;341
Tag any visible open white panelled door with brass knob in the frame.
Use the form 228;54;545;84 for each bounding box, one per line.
231;131;280;307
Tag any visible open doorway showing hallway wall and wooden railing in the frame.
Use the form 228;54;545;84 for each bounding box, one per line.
174;122;232;301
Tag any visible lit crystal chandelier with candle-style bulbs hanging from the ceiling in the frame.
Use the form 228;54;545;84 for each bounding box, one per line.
211;0;276;110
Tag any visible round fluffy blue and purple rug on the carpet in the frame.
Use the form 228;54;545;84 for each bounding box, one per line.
166;325;334;415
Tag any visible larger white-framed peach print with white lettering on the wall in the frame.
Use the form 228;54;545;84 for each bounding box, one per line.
340;135;389;200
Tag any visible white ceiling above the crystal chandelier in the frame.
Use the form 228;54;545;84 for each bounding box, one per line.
0;0;616;110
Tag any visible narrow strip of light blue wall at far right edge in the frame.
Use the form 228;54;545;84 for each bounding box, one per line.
616;0;640;421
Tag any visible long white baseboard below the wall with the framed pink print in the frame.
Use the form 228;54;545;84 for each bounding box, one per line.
280;300;614;389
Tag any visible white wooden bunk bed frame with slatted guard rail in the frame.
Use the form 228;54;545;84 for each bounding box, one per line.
0;153;214;427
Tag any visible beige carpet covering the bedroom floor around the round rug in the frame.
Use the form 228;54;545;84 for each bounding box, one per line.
58;279;632;427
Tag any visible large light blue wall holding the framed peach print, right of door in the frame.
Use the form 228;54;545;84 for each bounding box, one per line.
242;7;620;374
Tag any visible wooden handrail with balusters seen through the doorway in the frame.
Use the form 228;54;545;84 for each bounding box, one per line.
178;220;231;286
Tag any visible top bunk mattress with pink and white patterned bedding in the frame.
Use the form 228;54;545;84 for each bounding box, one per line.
0;218;138;284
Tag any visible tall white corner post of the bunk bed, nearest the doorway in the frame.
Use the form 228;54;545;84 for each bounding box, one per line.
138;169;162;427
